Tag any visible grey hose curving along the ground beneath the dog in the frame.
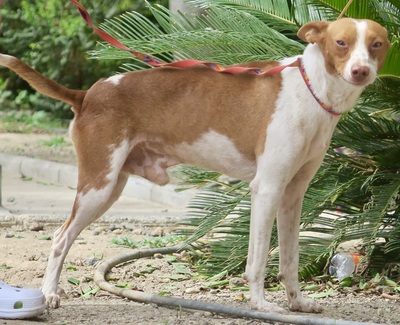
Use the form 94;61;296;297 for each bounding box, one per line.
94;246;377;325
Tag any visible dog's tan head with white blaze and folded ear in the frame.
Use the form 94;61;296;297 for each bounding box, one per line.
297;18;390;86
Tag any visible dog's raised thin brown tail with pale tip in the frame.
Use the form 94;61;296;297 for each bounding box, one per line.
0;54;86;112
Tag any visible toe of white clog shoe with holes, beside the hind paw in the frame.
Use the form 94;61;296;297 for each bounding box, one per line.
0;281;46;319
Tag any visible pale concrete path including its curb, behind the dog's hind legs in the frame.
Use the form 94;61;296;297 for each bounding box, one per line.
0;153;193;226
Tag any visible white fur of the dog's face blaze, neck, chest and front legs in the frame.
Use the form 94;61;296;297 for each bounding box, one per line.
246;19;384;312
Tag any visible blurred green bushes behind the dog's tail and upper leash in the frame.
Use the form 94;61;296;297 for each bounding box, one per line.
0;0;166;119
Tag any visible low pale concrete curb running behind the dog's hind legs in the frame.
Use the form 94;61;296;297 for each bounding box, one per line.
0;153;197;208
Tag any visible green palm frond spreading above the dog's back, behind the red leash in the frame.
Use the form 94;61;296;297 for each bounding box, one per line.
91;6;303;68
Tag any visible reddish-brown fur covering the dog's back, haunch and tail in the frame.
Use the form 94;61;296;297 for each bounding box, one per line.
1;56;281;186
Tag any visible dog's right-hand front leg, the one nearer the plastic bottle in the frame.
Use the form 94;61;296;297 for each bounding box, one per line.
277;159;322;312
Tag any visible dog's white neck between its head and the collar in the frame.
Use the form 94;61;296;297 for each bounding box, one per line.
303;44;364;113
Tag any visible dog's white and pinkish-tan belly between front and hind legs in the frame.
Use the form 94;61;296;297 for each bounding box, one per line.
124;131;256;185
